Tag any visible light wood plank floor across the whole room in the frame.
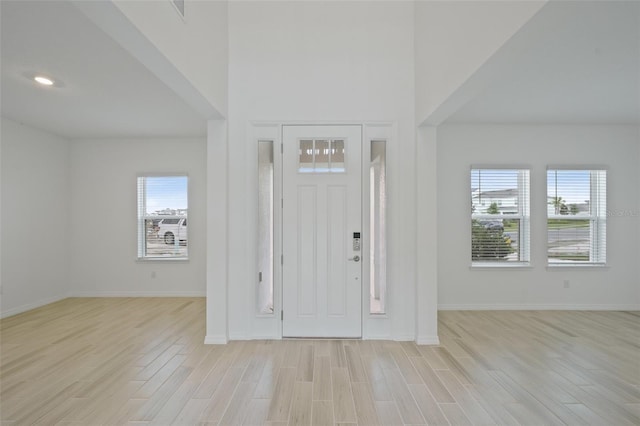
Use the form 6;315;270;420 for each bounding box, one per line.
0;298;640;425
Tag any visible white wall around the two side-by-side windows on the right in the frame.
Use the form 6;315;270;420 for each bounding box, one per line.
437;125;640;309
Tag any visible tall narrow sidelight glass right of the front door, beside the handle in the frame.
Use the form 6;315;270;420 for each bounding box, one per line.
369;141;387;314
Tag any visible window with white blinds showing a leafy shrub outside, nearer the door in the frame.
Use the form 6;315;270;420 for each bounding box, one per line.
471;168;530;266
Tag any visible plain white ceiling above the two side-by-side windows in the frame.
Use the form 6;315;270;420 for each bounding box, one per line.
445;1;640;124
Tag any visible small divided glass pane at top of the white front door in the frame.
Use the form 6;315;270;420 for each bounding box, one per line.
298;139;346;173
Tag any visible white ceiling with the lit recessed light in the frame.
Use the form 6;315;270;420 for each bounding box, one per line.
0;0;206;139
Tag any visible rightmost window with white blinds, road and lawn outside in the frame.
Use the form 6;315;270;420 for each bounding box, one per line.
547;168;607;266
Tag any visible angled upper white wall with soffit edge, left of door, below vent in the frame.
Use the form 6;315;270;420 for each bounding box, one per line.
72;0;228;119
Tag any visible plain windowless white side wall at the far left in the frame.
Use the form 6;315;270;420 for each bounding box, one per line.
0;118;70;317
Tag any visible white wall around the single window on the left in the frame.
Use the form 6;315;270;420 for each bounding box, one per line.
70;139;206;296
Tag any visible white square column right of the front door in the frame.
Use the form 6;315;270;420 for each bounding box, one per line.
416;126;440;345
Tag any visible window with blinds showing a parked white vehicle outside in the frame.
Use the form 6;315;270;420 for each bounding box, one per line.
138;175;189;260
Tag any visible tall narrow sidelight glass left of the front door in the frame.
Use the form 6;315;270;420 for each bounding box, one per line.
257;141;273;314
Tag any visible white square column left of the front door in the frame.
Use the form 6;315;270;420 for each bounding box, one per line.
204;120;229;344
